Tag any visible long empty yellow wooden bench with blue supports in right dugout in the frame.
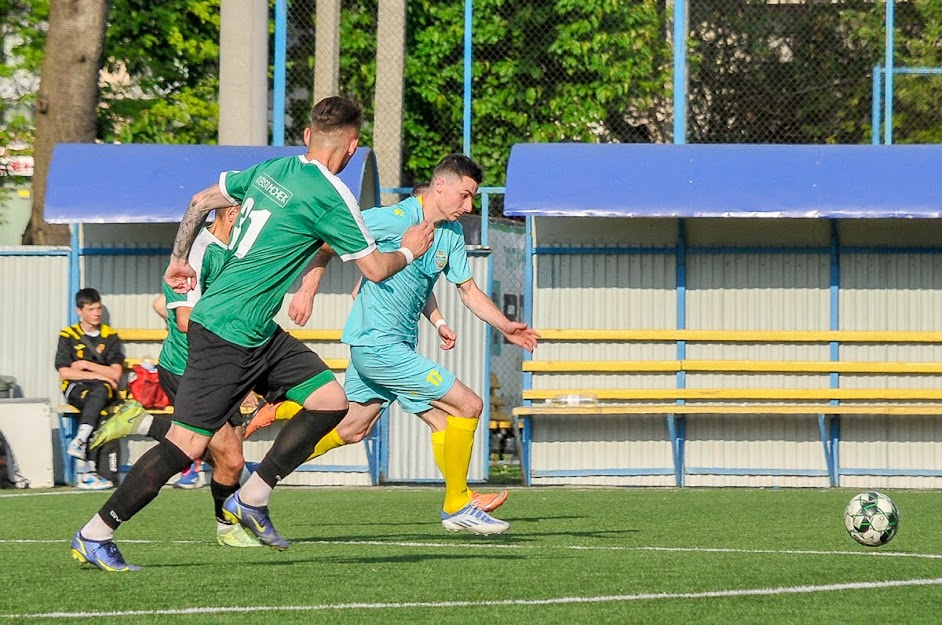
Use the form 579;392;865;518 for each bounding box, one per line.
513;330;942;486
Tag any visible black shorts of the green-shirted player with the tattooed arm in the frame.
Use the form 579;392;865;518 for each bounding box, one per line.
173;321;336;432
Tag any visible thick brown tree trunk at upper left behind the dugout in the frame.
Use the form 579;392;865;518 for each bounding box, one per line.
23;0;111;245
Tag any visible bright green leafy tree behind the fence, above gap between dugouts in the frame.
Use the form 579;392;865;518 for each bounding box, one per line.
286;0;670;184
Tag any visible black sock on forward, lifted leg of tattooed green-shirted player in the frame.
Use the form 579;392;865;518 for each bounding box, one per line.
255;410;347;488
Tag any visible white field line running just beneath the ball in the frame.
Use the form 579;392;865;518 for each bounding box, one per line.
0;538;942;560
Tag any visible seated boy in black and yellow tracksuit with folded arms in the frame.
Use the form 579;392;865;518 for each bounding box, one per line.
55;288;124;490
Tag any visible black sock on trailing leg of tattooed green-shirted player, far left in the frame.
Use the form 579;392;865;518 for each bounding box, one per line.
98;439;192;529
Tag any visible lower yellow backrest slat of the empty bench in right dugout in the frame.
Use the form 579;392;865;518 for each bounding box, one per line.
523;360;942;375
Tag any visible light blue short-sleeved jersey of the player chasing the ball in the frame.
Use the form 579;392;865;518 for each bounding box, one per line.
340;198;473;347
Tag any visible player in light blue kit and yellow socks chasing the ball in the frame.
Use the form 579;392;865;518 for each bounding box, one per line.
276;154;539;534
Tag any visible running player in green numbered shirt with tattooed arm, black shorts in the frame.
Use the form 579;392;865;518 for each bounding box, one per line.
71;97;433;571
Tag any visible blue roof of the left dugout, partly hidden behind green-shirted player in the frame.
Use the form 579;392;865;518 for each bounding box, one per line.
45;143;379;223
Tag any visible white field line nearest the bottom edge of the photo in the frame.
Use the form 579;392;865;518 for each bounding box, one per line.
0;577;942;620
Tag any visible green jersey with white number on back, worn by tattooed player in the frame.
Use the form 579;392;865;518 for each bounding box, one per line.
191;156;376;347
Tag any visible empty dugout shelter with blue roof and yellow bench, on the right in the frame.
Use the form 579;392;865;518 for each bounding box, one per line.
504;143;942;488
